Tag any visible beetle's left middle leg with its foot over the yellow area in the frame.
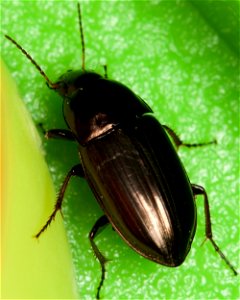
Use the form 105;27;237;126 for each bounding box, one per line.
35;164;84;238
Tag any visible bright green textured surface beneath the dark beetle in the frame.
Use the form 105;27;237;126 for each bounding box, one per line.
1;0;239;299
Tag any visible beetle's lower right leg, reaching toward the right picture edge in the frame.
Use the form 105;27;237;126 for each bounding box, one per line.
192;184;238;275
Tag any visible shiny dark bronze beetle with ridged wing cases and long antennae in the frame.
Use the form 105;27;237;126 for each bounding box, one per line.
5;4;237;299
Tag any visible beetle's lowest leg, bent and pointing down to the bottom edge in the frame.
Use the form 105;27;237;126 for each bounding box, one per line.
89;216;109;299
